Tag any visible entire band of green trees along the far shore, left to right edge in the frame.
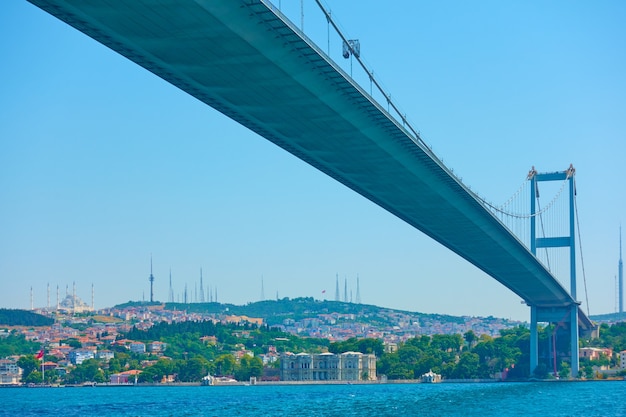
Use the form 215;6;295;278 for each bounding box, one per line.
9;314;626;384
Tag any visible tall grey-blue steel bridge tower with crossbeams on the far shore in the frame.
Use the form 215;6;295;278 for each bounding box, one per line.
528;165;580;377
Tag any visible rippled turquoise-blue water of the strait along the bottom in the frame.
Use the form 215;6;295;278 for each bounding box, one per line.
0;381;626;417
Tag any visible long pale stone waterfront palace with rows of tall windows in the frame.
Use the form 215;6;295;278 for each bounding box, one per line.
280;352;376;381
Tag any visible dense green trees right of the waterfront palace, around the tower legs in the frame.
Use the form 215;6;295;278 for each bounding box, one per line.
360;323;626;380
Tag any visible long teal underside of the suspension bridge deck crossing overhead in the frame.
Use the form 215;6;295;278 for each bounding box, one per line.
29;0;590;325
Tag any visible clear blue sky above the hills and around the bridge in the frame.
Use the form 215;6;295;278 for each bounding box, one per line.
0;0;626;320
